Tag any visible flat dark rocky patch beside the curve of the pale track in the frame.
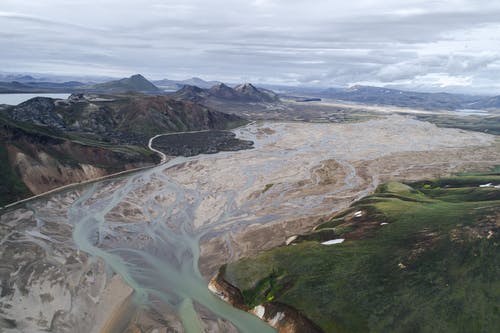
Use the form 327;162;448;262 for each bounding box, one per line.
154;130;253;156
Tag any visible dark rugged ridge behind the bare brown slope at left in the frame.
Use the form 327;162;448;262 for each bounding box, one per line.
2;94;244;145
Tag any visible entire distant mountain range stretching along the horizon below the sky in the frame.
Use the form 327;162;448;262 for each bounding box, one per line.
0;74;500;110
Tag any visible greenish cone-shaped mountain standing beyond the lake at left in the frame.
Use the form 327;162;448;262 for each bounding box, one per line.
85;74;162;93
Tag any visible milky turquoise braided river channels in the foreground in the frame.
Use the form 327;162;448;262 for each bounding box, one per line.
64;160;275;333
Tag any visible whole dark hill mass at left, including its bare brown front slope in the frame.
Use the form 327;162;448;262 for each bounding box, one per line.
0;94;246;204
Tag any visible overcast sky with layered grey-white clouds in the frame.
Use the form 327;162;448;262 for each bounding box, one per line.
0;0;500;93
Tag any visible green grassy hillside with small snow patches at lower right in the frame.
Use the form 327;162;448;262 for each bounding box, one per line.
225;172;500;332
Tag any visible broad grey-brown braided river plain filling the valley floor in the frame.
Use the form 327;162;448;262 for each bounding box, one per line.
0;116;500;332
